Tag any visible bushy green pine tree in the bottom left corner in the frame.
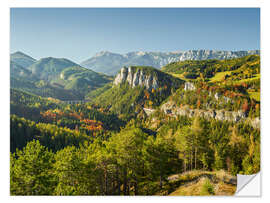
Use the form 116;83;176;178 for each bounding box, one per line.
10;140;56;195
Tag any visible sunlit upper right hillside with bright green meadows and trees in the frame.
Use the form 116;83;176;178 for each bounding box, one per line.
162;55;260;82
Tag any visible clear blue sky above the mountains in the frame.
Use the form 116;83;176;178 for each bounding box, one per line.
10;8;260;63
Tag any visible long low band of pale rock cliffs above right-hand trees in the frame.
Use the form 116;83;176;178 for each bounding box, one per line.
161;101;260;128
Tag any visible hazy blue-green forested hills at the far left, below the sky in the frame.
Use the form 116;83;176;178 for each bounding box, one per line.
10;52;112;100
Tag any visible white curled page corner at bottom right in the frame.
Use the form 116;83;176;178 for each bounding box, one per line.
235;172;261;197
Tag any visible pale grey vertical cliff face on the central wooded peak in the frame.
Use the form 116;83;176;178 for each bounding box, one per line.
113;67;160;90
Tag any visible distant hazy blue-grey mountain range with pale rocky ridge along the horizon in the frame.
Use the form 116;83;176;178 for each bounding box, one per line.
80;50;260;75
